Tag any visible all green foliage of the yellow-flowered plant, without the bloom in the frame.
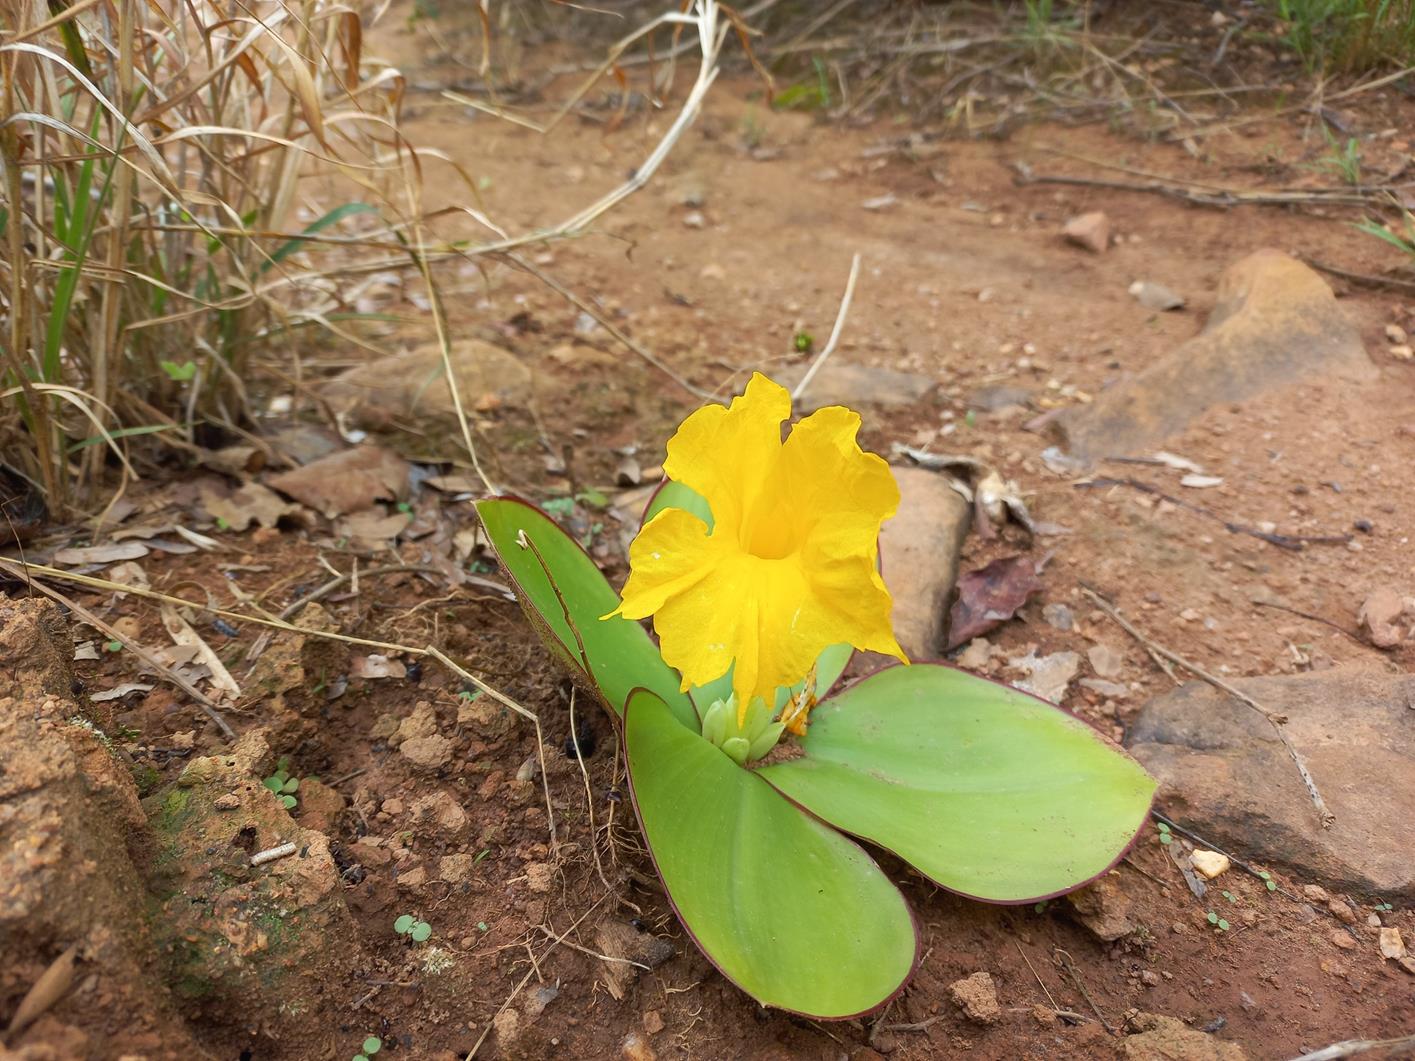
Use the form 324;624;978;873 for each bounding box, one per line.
477;482;1155;1019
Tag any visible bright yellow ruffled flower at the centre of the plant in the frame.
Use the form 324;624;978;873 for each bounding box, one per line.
613;372;908;714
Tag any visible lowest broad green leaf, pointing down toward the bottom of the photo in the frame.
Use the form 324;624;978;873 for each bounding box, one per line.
624;689;918;1019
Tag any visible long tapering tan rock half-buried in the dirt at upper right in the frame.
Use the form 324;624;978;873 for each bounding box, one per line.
1054;250;1375;461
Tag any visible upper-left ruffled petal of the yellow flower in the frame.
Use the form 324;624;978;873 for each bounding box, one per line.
664;372;791;532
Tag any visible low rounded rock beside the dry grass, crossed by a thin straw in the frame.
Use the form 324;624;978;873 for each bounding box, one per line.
320;338;533;427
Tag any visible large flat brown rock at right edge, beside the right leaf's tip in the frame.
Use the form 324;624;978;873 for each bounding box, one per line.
1126;669;1415;900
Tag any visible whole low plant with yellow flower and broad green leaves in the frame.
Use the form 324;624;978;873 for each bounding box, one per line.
477;373;1156;1019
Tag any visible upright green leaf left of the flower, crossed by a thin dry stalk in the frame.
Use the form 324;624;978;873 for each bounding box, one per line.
477;498;698;730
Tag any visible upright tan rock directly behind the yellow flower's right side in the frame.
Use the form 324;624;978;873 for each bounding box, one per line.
880;468;972;659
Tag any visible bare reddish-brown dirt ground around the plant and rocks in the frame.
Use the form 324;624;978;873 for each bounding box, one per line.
8;3;1415;1061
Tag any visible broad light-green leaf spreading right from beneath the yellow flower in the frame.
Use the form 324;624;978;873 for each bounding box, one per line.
758;663;1155;903
